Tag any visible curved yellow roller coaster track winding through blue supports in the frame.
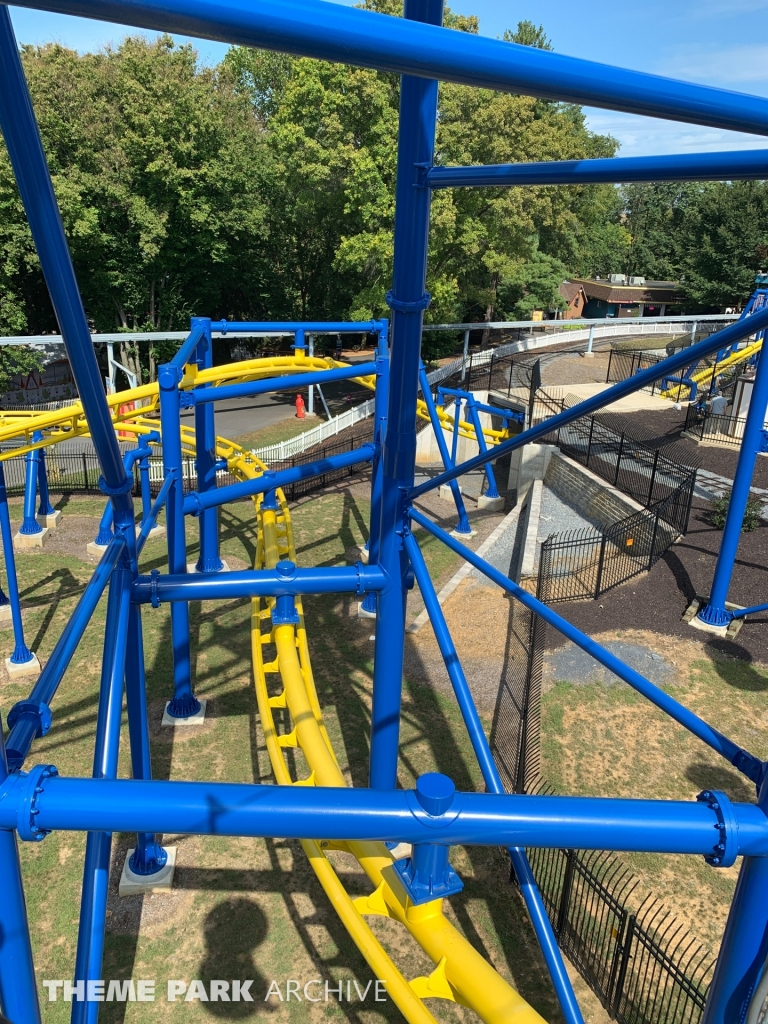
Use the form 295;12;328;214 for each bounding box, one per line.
7;356;543;1024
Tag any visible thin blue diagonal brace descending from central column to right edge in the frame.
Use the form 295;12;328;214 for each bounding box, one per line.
411;508;762;782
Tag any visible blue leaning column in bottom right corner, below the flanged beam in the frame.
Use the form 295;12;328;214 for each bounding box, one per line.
701;779;768;1024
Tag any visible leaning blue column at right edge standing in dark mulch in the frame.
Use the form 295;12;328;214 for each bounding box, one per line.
697;348;768;626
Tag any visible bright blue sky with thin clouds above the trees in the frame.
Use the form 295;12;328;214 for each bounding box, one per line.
11;0;768;157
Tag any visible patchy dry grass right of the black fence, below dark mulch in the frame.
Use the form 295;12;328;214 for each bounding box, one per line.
542;655;768;950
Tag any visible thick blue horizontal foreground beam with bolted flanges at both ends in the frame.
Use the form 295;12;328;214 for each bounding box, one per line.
0;765;768;861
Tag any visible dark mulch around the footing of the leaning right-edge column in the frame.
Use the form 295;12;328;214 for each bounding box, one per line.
548;500;768;663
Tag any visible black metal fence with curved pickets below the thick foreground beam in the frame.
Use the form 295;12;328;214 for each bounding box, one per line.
527;849;715;1024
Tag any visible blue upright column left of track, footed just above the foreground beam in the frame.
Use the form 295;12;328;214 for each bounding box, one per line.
158;364;200;718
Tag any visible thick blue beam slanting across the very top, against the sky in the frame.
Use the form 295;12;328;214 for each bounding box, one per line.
10;0;768;135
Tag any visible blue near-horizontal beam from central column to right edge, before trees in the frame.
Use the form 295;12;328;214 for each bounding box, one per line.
427;150;768;188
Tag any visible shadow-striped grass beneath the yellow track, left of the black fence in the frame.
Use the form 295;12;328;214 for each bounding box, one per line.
6;494;583;1024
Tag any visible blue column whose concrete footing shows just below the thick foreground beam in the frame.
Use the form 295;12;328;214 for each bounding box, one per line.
125;604;168;874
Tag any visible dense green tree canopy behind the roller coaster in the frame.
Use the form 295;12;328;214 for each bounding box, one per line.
0;0;768;379
